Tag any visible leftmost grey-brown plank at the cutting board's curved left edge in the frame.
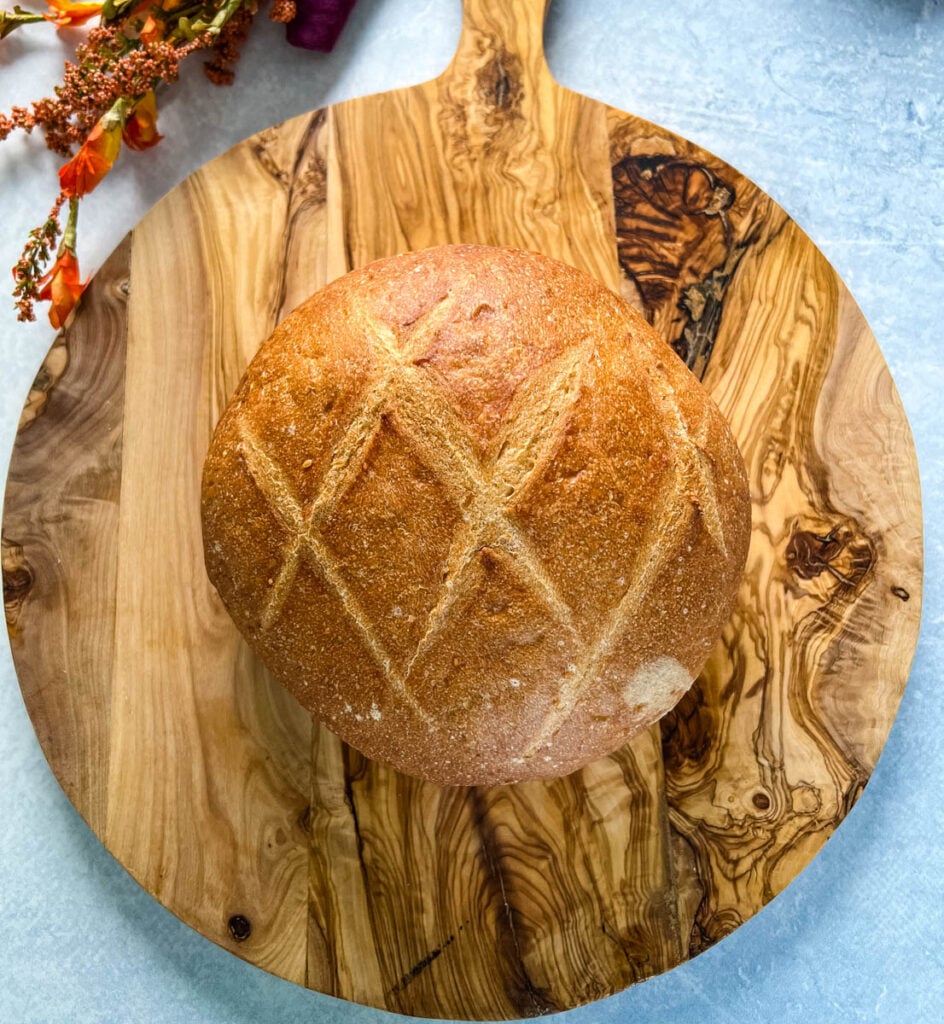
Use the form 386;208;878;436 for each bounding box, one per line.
3;240;131;836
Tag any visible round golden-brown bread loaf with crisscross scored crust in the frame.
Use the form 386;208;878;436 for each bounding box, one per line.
203;246;750;785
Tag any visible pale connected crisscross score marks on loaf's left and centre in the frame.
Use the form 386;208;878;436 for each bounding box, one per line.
233;288;590;714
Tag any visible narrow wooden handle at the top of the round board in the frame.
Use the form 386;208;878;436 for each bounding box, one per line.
441;0;551;88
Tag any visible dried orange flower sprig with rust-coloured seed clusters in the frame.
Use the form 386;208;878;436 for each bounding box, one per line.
0;0;295;328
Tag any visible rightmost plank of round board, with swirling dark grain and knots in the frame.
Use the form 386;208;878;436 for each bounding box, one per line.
610;112;921;953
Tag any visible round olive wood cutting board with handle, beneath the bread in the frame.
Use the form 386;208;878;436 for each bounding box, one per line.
3;0;921;1019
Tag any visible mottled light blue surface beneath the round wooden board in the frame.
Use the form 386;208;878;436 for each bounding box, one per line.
0;0;944;1024
